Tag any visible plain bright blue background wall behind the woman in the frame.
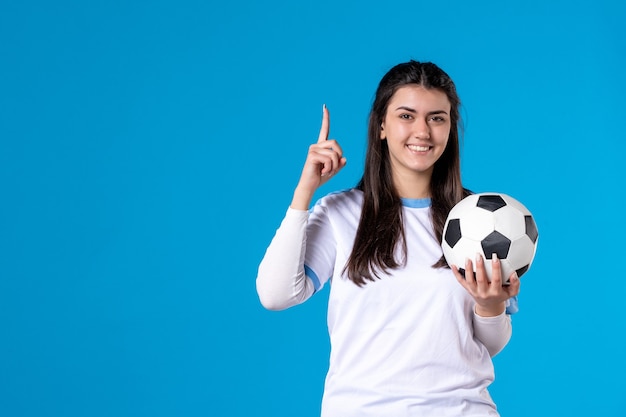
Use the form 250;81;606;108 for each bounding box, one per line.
0;0;626;417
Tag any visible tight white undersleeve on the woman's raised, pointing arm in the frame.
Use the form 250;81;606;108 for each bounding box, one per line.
256;208;315;310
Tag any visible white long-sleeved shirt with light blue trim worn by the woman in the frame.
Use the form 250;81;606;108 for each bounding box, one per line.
257;189;511;417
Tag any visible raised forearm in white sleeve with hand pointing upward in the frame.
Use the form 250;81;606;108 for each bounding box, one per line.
256;106;346;310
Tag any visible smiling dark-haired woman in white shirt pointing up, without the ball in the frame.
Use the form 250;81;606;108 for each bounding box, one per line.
256;61;520;417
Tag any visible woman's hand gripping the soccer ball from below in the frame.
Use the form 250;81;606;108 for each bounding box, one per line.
451;254;520;317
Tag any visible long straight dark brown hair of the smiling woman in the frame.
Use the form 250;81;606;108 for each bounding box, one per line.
344;60;469;286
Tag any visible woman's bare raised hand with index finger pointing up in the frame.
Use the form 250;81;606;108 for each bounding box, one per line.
291;106;346;210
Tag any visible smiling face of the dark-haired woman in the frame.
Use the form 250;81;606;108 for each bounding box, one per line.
380;84;451;181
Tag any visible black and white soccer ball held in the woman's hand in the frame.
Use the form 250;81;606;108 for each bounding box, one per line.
441;193;539;284
